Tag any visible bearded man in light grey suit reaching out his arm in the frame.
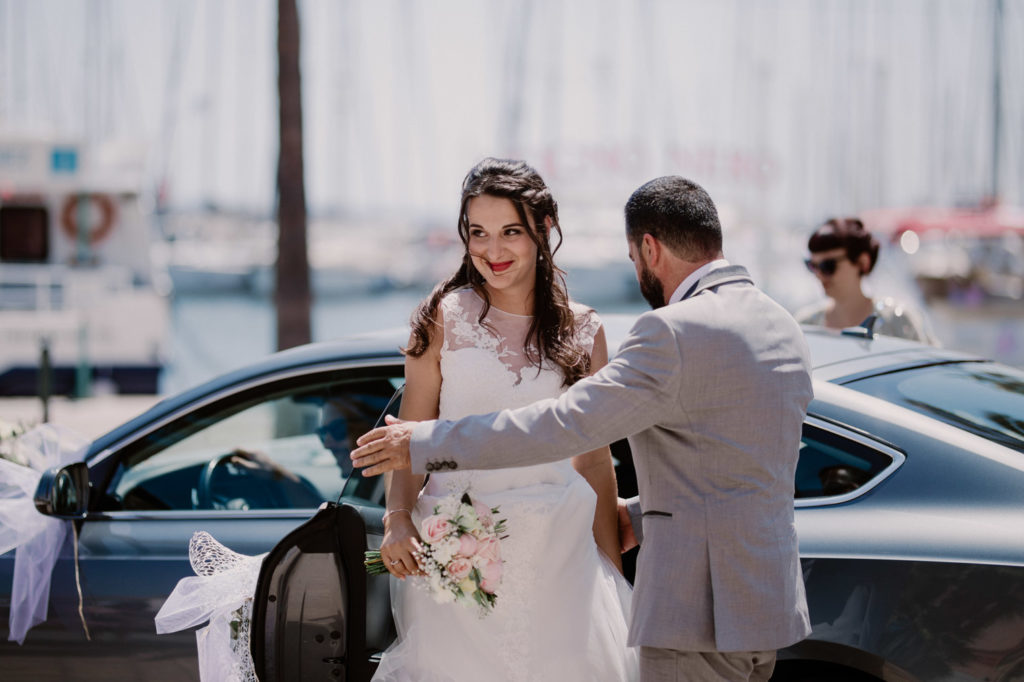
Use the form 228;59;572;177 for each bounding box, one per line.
352;177;811;682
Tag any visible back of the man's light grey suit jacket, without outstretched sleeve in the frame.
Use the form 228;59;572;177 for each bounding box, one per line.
630;283;811;650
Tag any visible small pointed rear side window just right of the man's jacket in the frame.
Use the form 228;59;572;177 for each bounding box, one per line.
796;418;902;502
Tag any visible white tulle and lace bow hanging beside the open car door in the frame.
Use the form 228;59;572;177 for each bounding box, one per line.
156;530;266;682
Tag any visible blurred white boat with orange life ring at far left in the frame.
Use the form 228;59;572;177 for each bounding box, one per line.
0;134;170;396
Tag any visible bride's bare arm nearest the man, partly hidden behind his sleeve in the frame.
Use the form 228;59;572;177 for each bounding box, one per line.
572;327;623;572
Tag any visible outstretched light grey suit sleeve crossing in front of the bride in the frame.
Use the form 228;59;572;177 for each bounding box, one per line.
410;313;680;473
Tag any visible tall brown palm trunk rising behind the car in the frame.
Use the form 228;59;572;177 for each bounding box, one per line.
274;0;311;350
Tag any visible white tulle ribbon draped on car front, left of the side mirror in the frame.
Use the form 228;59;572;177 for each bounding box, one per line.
0;424;89;644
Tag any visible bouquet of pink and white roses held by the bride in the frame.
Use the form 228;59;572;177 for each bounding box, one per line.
364;493;505;615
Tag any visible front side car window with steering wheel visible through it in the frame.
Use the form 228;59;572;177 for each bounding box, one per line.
101;368;402;511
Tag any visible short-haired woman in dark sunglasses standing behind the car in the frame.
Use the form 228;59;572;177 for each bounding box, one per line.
796;218;937;345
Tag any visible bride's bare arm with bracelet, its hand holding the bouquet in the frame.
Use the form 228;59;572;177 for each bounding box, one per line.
381;323;443;578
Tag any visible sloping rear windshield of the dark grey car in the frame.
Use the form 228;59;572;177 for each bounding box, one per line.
845;363;1024;453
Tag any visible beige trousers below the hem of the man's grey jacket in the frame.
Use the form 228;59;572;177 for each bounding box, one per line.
640;646;775;682
